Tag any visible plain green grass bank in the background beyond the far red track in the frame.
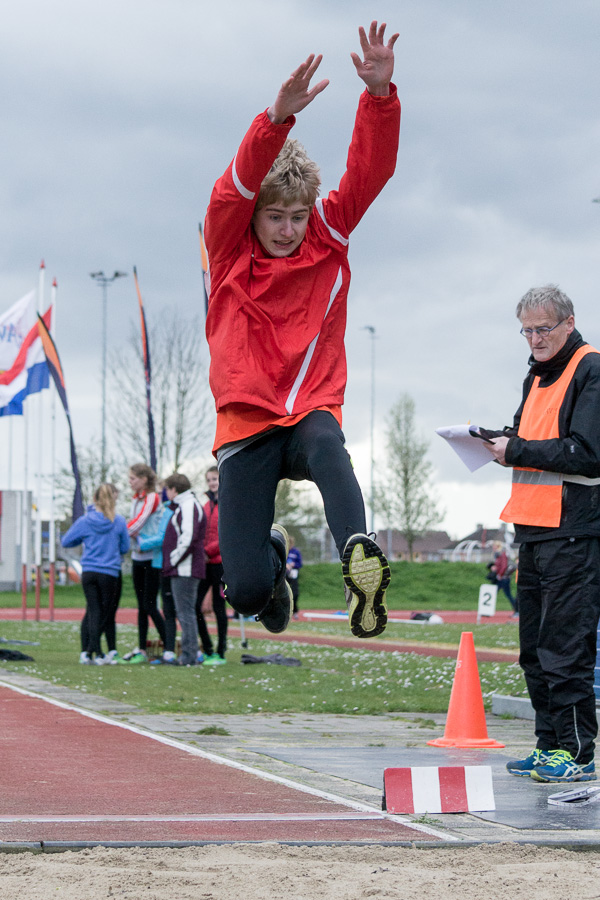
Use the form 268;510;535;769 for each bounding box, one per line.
0;562;510;610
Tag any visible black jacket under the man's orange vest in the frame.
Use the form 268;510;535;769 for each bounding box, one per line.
506;331;600;542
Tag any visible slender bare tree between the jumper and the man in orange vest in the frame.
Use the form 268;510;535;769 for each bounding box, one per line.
376;394;443;559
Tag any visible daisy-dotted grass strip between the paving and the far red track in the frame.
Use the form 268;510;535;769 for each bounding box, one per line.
0;621;525;715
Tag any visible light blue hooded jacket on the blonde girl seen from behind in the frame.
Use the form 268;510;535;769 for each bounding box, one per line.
60;506;129;575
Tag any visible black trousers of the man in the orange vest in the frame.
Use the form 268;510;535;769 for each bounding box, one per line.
517;537;600;764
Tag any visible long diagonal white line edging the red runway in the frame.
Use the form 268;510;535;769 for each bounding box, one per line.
0;679;452;842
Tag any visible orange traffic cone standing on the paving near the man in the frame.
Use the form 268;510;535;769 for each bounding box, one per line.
427;631;505;747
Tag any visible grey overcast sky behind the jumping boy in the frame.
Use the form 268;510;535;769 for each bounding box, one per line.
0;0;600;536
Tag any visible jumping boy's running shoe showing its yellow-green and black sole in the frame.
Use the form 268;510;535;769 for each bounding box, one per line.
342;534;390;638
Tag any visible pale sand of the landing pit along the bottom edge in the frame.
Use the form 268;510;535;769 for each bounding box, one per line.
0;843;600;900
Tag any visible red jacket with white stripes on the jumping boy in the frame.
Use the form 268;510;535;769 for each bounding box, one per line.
205;85;400;444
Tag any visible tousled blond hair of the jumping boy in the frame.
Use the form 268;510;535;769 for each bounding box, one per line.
256;138;321;211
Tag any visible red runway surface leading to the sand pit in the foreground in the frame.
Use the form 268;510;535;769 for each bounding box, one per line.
0;687;436;843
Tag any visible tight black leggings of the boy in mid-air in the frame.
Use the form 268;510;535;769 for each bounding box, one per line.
219;410;366;616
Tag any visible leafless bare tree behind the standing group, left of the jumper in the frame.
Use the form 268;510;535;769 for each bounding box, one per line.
108;310;214;473
